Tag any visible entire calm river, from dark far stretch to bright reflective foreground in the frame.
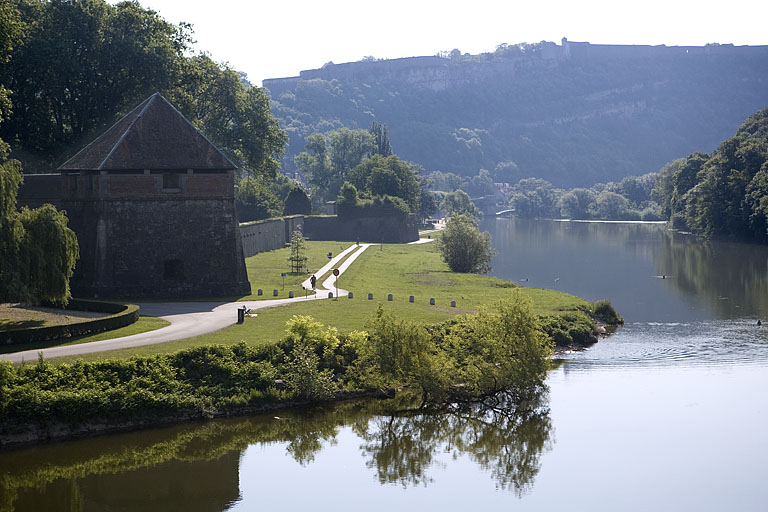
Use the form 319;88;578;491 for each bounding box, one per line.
0;219;768;511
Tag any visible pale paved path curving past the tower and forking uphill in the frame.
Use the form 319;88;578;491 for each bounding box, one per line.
0;244;370;363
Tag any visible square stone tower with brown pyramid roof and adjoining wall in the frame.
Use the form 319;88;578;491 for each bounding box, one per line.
19;93;250;298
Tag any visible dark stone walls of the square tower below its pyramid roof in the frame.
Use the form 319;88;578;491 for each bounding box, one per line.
19;172;250;298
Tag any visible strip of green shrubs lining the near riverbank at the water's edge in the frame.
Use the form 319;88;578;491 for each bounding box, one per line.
0;294;551;430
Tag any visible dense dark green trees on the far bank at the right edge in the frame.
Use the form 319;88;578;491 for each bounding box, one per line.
654;109;768;242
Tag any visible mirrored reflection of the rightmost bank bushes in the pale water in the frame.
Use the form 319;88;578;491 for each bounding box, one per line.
356;388;552;496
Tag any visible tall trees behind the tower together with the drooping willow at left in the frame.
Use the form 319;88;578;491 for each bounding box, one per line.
0;0;288;303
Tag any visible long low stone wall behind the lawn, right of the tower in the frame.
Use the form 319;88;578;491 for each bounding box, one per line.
240;215;419;258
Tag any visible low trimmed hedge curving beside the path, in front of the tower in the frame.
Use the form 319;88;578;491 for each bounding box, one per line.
0;299;139;345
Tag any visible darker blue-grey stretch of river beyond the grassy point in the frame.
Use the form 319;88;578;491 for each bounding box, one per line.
482;219;768;322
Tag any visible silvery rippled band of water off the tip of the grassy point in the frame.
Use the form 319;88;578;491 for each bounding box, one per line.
560;319;768;370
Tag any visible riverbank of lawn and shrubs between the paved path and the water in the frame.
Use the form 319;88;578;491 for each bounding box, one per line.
0;240;620;446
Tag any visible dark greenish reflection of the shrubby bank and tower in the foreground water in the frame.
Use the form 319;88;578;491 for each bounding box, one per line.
0;390;551;511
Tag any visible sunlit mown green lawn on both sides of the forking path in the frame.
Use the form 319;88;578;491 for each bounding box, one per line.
51;242;587;363
